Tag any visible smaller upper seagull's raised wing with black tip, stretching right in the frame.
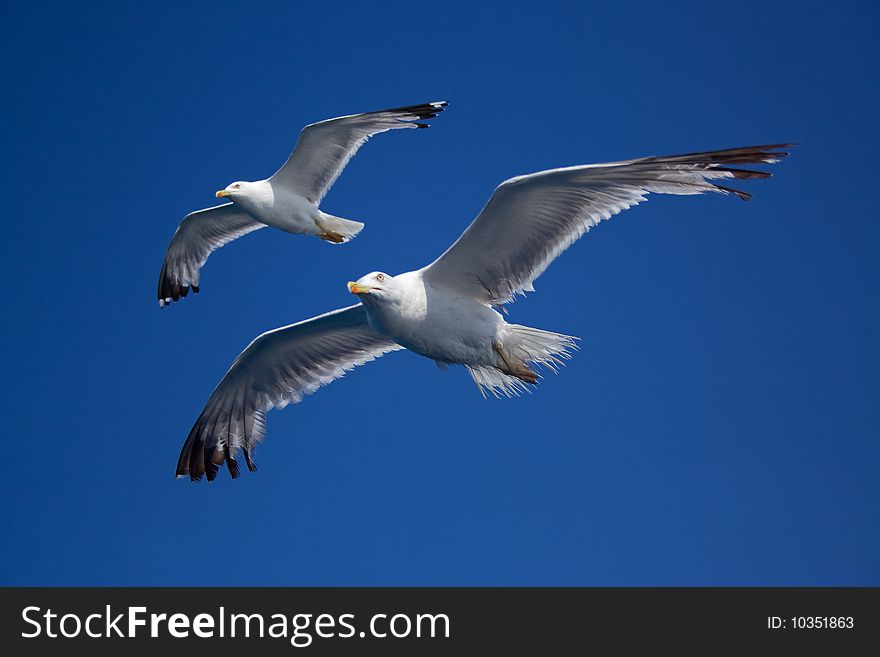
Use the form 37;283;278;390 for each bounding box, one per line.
269;100;447;204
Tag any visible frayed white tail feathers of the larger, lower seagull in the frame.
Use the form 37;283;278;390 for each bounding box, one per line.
468;324;579;398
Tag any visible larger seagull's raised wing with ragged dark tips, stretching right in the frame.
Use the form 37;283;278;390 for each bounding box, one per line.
424;144;792;304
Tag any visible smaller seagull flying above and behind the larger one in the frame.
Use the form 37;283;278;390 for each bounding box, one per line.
159;101;448;307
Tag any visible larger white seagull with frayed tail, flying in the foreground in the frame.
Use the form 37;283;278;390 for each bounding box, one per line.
177;144;791;481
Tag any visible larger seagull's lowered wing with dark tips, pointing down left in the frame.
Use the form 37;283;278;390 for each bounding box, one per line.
177;304;403;481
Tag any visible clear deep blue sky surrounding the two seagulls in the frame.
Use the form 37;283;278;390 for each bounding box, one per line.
0;1;880;585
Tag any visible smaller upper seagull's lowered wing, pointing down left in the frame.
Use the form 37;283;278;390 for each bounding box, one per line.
159;203;266;307
